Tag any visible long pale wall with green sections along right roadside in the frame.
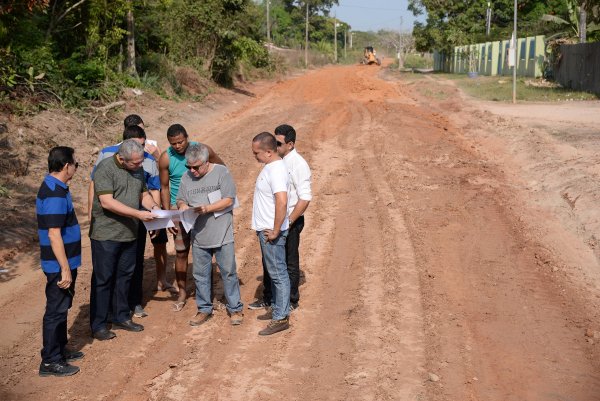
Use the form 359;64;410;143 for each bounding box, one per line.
433;35;545;78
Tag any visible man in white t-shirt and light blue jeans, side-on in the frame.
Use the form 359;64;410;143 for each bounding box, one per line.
252;132;290;336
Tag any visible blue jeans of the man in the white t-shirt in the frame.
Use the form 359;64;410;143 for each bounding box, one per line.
256;230;290;320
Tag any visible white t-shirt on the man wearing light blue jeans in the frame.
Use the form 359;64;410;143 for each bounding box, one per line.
252;160;290;231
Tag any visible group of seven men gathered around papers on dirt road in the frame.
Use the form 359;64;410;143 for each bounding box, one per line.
36;115;311;376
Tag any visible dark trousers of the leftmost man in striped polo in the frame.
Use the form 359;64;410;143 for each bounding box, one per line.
42;269;77;363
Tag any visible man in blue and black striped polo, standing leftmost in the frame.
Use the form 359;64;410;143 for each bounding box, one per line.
36;146;83;376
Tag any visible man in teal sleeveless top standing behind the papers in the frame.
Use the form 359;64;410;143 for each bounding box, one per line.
158;124;225;312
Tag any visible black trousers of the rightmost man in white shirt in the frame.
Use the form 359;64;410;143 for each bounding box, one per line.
263;216;304;305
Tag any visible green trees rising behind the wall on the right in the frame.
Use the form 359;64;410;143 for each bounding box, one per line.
408;0;600;52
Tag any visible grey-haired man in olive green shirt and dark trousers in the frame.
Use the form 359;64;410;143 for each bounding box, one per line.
90;139;160;340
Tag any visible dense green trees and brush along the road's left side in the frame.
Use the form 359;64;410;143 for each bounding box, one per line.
0;0;344;114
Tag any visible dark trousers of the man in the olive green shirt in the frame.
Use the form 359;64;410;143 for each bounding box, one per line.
90;239;137;332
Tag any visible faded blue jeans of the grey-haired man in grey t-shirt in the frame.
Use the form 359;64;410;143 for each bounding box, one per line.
192;242;244;313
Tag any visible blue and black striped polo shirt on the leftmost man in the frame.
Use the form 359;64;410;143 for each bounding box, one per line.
35;174;81;273
